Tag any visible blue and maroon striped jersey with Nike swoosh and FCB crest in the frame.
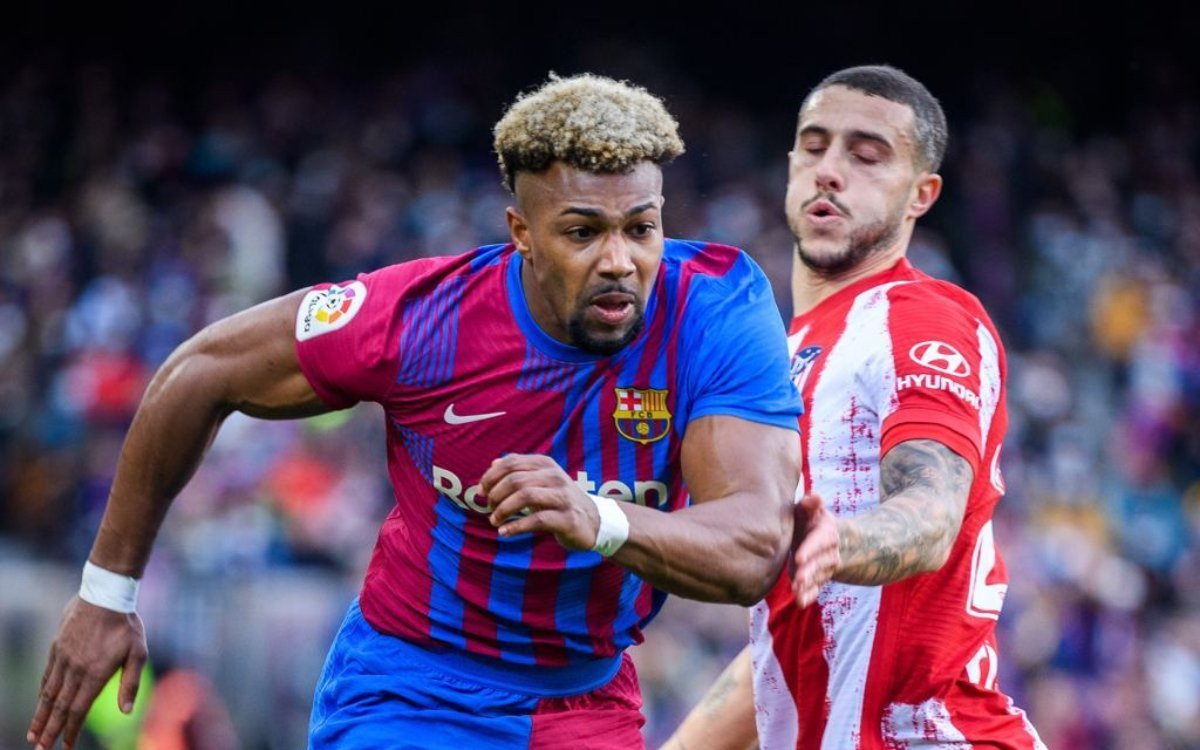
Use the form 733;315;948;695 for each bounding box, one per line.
296;240;800;666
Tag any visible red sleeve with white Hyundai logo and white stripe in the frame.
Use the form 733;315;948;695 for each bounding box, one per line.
880;283;1003;473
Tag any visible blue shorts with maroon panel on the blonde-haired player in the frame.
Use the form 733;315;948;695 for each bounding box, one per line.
308;601;646;750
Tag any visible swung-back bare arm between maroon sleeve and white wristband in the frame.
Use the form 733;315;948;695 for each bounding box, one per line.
89;292;328;577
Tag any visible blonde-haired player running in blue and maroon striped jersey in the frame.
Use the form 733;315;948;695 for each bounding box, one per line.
30;76;825;750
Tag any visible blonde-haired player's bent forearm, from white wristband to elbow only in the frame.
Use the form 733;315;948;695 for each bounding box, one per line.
612;494;792;606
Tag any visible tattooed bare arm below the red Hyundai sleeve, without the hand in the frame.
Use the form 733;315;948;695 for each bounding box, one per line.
834;440;974;586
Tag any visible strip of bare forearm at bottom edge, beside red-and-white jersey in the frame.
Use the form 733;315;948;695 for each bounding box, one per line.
662;648;757;750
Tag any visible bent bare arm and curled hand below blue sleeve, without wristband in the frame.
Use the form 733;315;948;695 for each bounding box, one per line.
480;415;799;605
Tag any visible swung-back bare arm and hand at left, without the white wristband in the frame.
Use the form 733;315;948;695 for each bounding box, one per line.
26;293;328;750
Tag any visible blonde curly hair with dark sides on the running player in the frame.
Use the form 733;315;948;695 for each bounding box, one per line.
493;73;684;190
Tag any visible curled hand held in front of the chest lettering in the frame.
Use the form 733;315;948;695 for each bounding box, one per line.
479;454;600;550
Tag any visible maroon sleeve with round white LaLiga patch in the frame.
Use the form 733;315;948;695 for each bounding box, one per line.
295;266;403;409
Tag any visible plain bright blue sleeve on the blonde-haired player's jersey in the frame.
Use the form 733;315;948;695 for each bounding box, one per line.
680;252;804;430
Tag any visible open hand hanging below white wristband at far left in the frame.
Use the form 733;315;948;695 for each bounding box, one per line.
25;596;148;750
